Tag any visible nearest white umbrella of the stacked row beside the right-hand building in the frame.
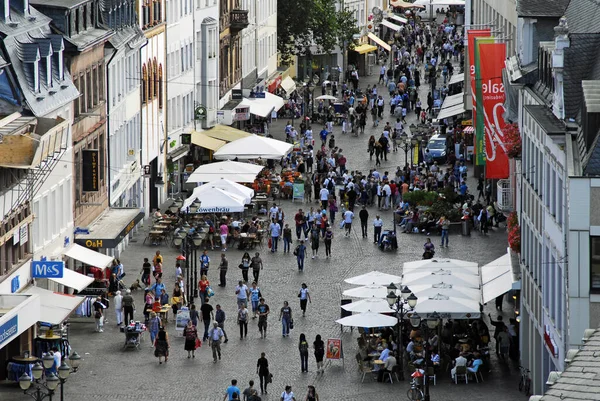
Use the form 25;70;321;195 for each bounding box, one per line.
415;294;480;319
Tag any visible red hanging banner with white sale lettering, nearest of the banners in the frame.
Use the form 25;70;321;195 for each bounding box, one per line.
475;39;509;179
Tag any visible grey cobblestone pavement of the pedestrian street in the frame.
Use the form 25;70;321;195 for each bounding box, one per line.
0;63;525;401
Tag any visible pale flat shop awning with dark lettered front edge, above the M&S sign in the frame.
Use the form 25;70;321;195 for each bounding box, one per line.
75;208;144;248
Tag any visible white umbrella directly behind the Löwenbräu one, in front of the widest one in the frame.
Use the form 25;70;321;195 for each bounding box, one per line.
186;160;264;183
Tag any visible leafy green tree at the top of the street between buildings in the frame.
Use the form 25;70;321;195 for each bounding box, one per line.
277;0;358;64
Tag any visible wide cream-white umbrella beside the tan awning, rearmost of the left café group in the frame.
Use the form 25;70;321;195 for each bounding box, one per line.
213;135;294;160
